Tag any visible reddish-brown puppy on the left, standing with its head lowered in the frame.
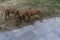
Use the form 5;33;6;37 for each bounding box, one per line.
3;8;21;24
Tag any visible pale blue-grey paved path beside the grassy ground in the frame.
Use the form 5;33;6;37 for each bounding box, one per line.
0;17;60;40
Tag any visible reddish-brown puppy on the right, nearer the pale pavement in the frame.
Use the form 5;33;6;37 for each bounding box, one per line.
23;10;43;21
